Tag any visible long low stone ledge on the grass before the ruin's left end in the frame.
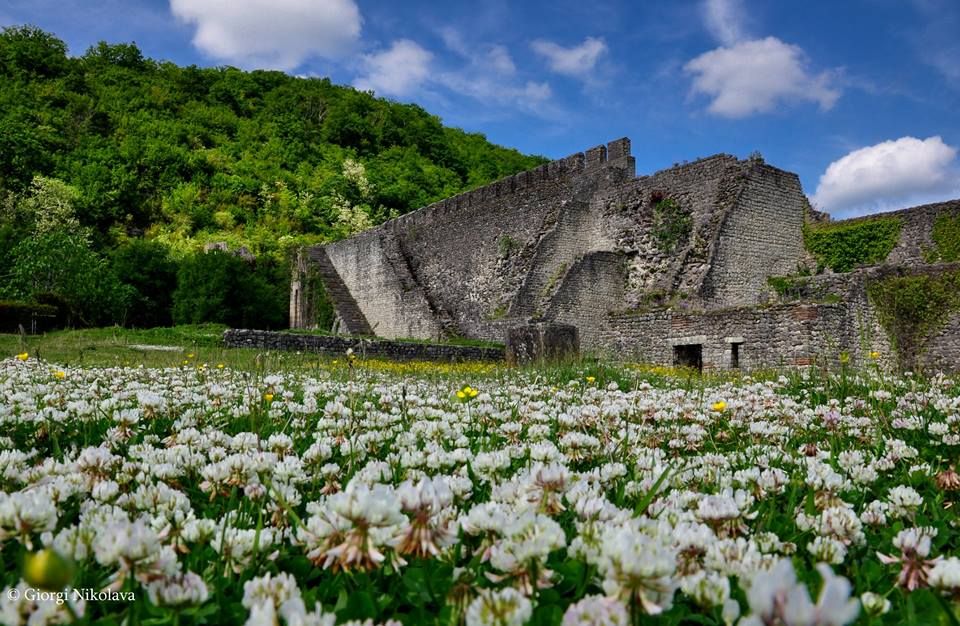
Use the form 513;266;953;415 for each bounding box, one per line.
223;328;503;361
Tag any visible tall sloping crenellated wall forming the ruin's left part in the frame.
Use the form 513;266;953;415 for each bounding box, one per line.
310;139;634;339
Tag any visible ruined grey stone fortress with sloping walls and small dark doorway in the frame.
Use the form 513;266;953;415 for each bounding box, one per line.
290;139;960;370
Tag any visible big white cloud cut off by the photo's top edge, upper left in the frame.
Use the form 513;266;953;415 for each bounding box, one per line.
170;0;361;70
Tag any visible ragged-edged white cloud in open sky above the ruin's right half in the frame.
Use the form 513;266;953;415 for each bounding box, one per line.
684;37;840;117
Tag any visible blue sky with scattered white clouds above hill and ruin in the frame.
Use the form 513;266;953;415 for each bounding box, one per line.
0;0;960;217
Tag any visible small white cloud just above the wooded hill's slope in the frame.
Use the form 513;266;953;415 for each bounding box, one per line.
353;39;433;96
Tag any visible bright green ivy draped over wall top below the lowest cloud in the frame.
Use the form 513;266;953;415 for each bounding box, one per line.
803;217;900;272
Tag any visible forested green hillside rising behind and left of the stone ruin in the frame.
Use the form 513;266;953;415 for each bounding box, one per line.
0;27;543;327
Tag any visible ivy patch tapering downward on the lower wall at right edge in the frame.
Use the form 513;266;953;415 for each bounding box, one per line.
867;271;960;369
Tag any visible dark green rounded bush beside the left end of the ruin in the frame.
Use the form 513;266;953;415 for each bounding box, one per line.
173;250;289;329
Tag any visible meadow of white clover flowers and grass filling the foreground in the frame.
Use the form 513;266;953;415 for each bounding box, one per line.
0;327;960;626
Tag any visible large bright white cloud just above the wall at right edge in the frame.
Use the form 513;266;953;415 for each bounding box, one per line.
812;136;960;216
